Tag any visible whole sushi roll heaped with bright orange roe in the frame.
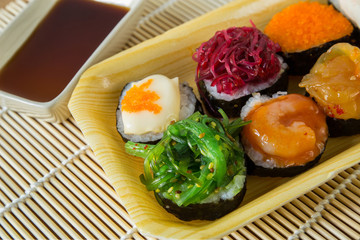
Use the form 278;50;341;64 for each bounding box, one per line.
264;2;359;76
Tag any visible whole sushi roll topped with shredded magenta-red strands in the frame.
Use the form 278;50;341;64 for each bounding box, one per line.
193;27;288;118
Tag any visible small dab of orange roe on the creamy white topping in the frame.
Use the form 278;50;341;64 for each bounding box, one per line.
121;79;162;114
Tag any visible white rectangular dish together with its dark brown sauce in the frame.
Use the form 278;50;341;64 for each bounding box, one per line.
0;0;145;122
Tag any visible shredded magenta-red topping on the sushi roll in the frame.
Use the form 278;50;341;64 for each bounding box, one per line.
193;26;281;95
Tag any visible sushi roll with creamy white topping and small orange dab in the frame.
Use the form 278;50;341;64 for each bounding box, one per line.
116;74;202;143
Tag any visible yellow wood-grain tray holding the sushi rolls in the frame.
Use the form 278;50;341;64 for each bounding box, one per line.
69;0;360;239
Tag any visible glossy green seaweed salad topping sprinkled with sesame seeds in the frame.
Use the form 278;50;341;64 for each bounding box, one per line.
125;110;247;210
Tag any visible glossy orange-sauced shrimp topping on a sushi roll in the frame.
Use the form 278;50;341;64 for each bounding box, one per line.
242;94;328;167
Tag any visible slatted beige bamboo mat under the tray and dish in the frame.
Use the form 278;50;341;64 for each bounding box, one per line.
0;0;360;240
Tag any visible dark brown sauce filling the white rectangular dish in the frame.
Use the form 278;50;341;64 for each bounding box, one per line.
0;0;129;102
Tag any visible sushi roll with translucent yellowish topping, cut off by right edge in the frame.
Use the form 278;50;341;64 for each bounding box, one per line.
299;43;360;137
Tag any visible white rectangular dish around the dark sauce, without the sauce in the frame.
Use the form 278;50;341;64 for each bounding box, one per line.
0;0;145;122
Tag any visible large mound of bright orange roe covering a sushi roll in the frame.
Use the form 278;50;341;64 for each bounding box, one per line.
264;2;353;52
